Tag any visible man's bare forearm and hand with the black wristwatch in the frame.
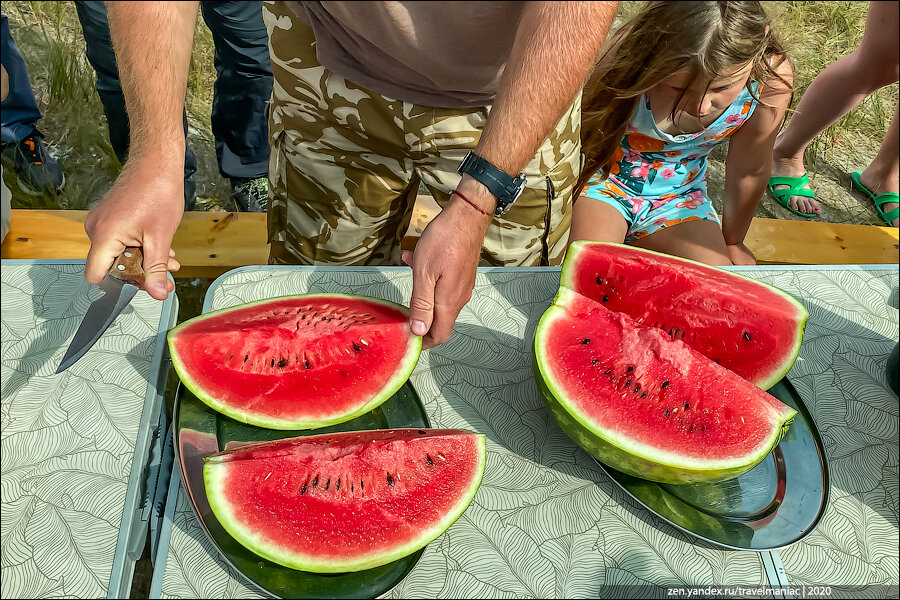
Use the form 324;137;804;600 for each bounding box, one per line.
403;2;618;348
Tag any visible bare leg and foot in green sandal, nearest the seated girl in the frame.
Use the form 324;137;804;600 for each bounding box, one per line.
772;2;900;213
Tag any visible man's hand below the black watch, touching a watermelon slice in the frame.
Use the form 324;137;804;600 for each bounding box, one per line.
403;184;493;348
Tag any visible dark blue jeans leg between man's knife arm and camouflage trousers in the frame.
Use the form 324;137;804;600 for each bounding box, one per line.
200;1;272;179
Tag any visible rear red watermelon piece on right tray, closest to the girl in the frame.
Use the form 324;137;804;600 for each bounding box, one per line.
560;241;808;390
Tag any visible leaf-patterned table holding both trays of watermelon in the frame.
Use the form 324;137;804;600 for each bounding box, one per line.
150;266;900;598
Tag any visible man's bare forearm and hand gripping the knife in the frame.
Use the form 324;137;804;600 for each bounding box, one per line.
84;1;198;299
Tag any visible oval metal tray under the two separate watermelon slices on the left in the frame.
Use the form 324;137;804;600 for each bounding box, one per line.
173;382;429;598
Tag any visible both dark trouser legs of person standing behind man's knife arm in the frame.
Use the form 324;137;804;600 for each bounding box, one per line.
75;0;272;179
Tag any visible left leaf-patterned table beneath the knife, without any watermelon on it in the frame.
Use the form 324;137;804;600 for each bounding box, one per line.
0;260;177;598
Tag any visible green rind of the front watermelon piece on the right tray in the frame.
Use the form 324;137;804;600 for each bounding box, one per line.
532;288;796;484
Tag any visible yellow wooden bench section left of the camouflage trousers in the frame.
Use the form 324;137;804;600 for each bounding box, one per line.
0;209;269;278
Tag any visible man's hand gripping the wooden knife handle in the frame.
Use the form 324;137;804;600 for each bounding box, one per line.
84;161;184;300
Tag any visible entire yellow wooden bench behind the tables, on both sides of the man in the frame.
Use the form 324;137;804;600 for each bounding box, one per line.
0;201;900;278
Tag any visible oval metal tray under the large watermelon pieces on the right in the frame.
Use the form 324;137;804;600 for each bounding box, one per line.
600;378;829;551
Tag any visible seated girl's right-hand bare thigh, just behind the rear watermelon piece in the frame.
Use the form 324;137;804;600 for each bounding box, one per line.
632;219;733;265
